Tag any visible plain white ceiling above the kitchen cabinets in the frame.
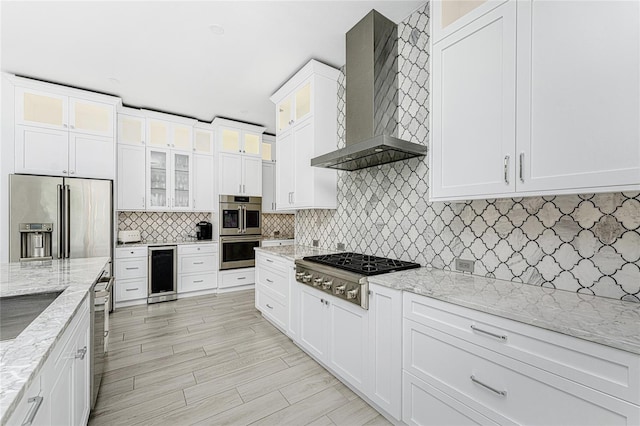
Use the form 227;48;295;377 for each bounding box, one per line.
0;0;425;133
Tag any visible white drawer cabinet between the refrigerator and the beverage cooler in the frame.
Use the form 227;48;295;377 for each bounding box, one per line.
115;246;149;308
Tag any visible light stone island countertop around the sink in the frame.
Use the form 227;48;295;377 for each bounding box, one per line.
0;257;109;424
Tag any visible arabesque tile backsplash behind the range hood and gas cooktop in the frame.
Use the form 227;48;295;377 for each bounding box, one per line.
295;6;640;302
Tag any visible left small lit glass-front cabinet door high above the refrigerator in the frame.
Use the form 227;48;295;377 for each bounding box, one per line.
15;87;69;130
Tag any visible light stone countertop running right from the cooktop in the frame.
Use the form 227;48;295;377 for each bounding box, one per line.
369;268;640;354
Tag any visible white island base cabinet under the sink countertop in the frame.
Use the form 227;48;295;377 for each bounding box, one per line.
7;297;92;425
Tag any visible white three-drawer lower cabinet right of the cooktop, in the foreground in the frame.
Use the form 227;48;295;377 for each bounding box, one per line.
403;293;640;425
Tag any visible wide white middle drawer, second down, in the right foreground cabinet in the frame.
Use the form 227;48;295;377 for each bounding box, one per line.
403;319;640;425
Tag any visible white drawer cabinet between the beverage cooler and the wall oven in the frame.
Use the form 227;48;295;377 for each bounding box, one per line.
178;243;218;297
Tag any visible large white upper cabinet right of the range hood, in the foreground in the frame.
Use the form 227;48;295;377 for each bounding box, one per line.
430;0;640;201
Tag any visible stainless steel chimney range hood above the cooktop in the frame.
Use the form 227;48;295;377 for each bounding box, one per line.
311;10;427;171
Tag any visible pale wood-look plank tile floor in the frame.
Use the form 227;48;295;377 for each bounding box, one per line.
89;290;390;426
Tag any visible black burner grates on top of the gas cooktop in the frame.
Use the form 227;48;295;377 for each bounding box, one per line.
304;253;420;276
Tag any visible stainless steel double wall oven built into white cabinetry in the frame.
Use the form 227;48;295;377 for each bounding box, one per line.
218;195;262;270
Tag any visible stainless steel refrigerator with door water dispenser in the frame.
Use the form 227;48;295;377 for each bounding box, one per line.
9;175;113;262
